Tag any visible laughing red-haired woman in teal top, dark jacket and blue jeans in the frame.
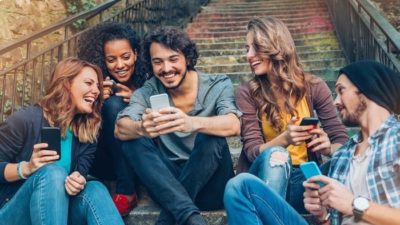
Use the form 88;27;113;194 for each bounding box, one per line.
0;58;123;225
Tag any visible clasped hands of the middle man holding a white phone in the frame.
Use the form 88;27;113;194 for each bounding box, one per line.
153;107;194;134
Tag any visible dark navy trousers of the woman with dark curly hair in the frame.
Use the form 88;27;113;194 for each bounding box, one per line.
90;95;136;195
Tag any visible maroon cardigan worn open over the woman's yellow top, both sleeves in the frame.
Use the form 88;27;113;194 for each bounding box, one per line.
236;75;348;173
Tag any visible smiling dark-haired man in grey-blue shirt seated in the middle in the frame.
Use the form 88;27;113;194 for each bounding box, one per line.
115;27;241;224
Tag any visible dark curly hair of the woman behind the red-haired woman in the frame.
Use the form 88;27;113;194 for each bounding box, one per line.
77;22;148;88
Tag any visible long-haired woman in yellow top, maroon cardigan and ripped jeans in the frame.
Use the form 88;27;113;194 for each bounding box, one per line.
236;17;348;213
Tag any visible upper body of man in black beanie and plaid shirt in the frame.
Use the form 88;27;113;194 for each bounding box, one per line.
304;61;400;225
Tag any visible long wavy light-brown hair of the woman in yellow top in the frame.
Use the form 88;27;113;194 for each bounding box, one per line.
247;17;306;132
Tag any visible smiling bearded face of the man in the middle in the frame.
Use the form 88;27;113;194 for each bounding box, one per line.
150;42;187;89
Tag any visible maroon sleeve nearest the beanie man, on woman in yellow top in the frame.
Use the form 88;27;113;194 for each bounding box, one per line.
312;79;348;144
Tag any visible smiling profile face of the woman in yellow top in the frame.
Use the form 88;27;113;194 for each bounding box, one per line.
246;32;270;76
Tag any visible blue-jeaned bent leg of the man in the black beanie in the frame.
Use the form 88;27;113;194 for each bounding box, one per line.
224;173;308;225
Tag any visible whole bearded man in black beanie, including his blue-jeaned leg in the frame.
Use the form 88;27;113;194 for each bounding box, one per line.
224;61;400;225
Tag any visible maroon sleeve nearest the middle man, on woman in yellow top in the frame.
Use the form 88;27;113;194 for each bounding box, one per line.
236;85;265;162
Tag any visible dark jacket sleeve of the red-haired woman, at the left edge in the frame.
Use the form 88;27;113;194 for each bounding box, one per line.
0;111;29;183
